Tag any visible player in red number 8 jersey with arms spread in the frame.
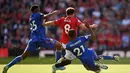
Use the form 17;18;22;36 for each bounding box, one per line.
43;7;98;69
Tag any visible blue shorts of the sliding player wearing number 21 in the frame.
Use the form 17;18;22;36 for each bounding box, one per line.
80;49;97;66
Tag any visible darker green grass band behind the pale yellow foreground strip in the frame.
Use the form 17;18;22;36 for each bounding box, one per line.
0;57;130;64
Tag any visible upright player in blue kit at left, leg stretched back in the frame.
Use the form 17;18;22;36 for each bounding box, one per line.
3;5;62;73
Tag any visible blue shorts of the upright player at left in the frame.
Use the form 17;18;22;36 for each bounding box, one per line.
26;38;56;52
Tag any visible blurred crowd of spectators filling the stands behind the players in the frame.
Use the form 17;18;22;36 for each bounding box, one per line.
0;0;130;50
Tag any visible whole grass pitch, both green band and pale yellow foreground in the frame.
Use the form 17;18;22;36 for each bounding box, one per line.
0;57;130;73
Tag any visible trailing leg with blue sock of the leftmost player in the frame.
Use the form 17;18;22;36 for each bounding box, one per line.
3;42;36;73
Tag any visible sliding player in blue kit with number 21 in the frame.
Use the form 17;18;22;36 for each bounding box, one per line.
52;24;119;73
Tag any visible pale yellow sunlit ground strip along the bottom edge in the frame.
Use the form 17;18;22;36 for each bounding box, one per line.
0;64;130;73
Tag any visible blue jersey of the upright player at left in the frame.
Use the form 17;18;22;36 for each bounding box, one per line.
29;12;46;39
